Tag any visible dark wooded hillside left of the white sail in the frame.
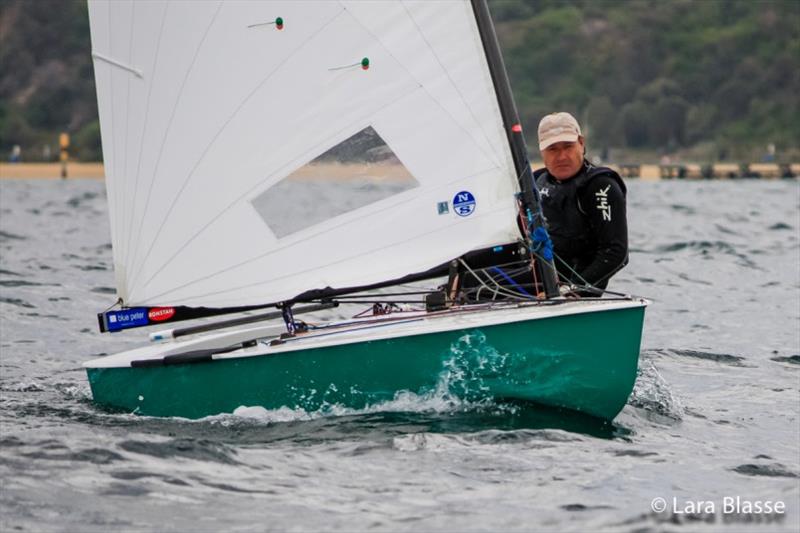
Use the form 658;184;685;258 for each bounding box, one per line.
0;0;100;161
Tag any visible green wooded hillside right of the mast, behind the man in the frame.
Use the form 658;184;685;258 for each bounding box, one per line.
490;0;800;158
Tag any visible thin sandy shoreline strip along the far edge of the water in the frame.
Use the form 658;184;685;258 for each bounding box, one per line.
0;162;800;181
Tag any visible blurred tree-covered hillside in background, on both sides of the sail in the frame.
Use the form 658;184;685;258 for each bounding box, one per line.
0;0;800;160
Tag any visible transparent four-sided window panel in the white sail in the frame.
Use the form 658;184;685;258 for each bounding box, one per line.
252;126;419;238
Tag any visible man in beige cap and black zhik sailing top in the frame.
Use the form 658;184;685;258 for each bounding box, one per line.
534;113;628;295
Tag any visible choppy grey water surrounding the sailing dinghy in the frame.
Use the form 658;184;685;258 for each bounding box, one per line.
0;180;800;531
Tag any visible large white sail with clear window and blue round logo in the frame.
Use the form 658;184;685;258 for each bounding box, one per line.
89;0;518;307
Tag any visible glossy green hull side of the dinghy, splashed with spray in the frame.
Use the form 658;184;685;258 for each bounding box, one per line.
87;306;644;420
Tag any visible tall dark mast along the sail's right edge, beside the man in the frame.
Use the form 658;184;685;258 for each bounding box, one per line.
471;0;559;298
